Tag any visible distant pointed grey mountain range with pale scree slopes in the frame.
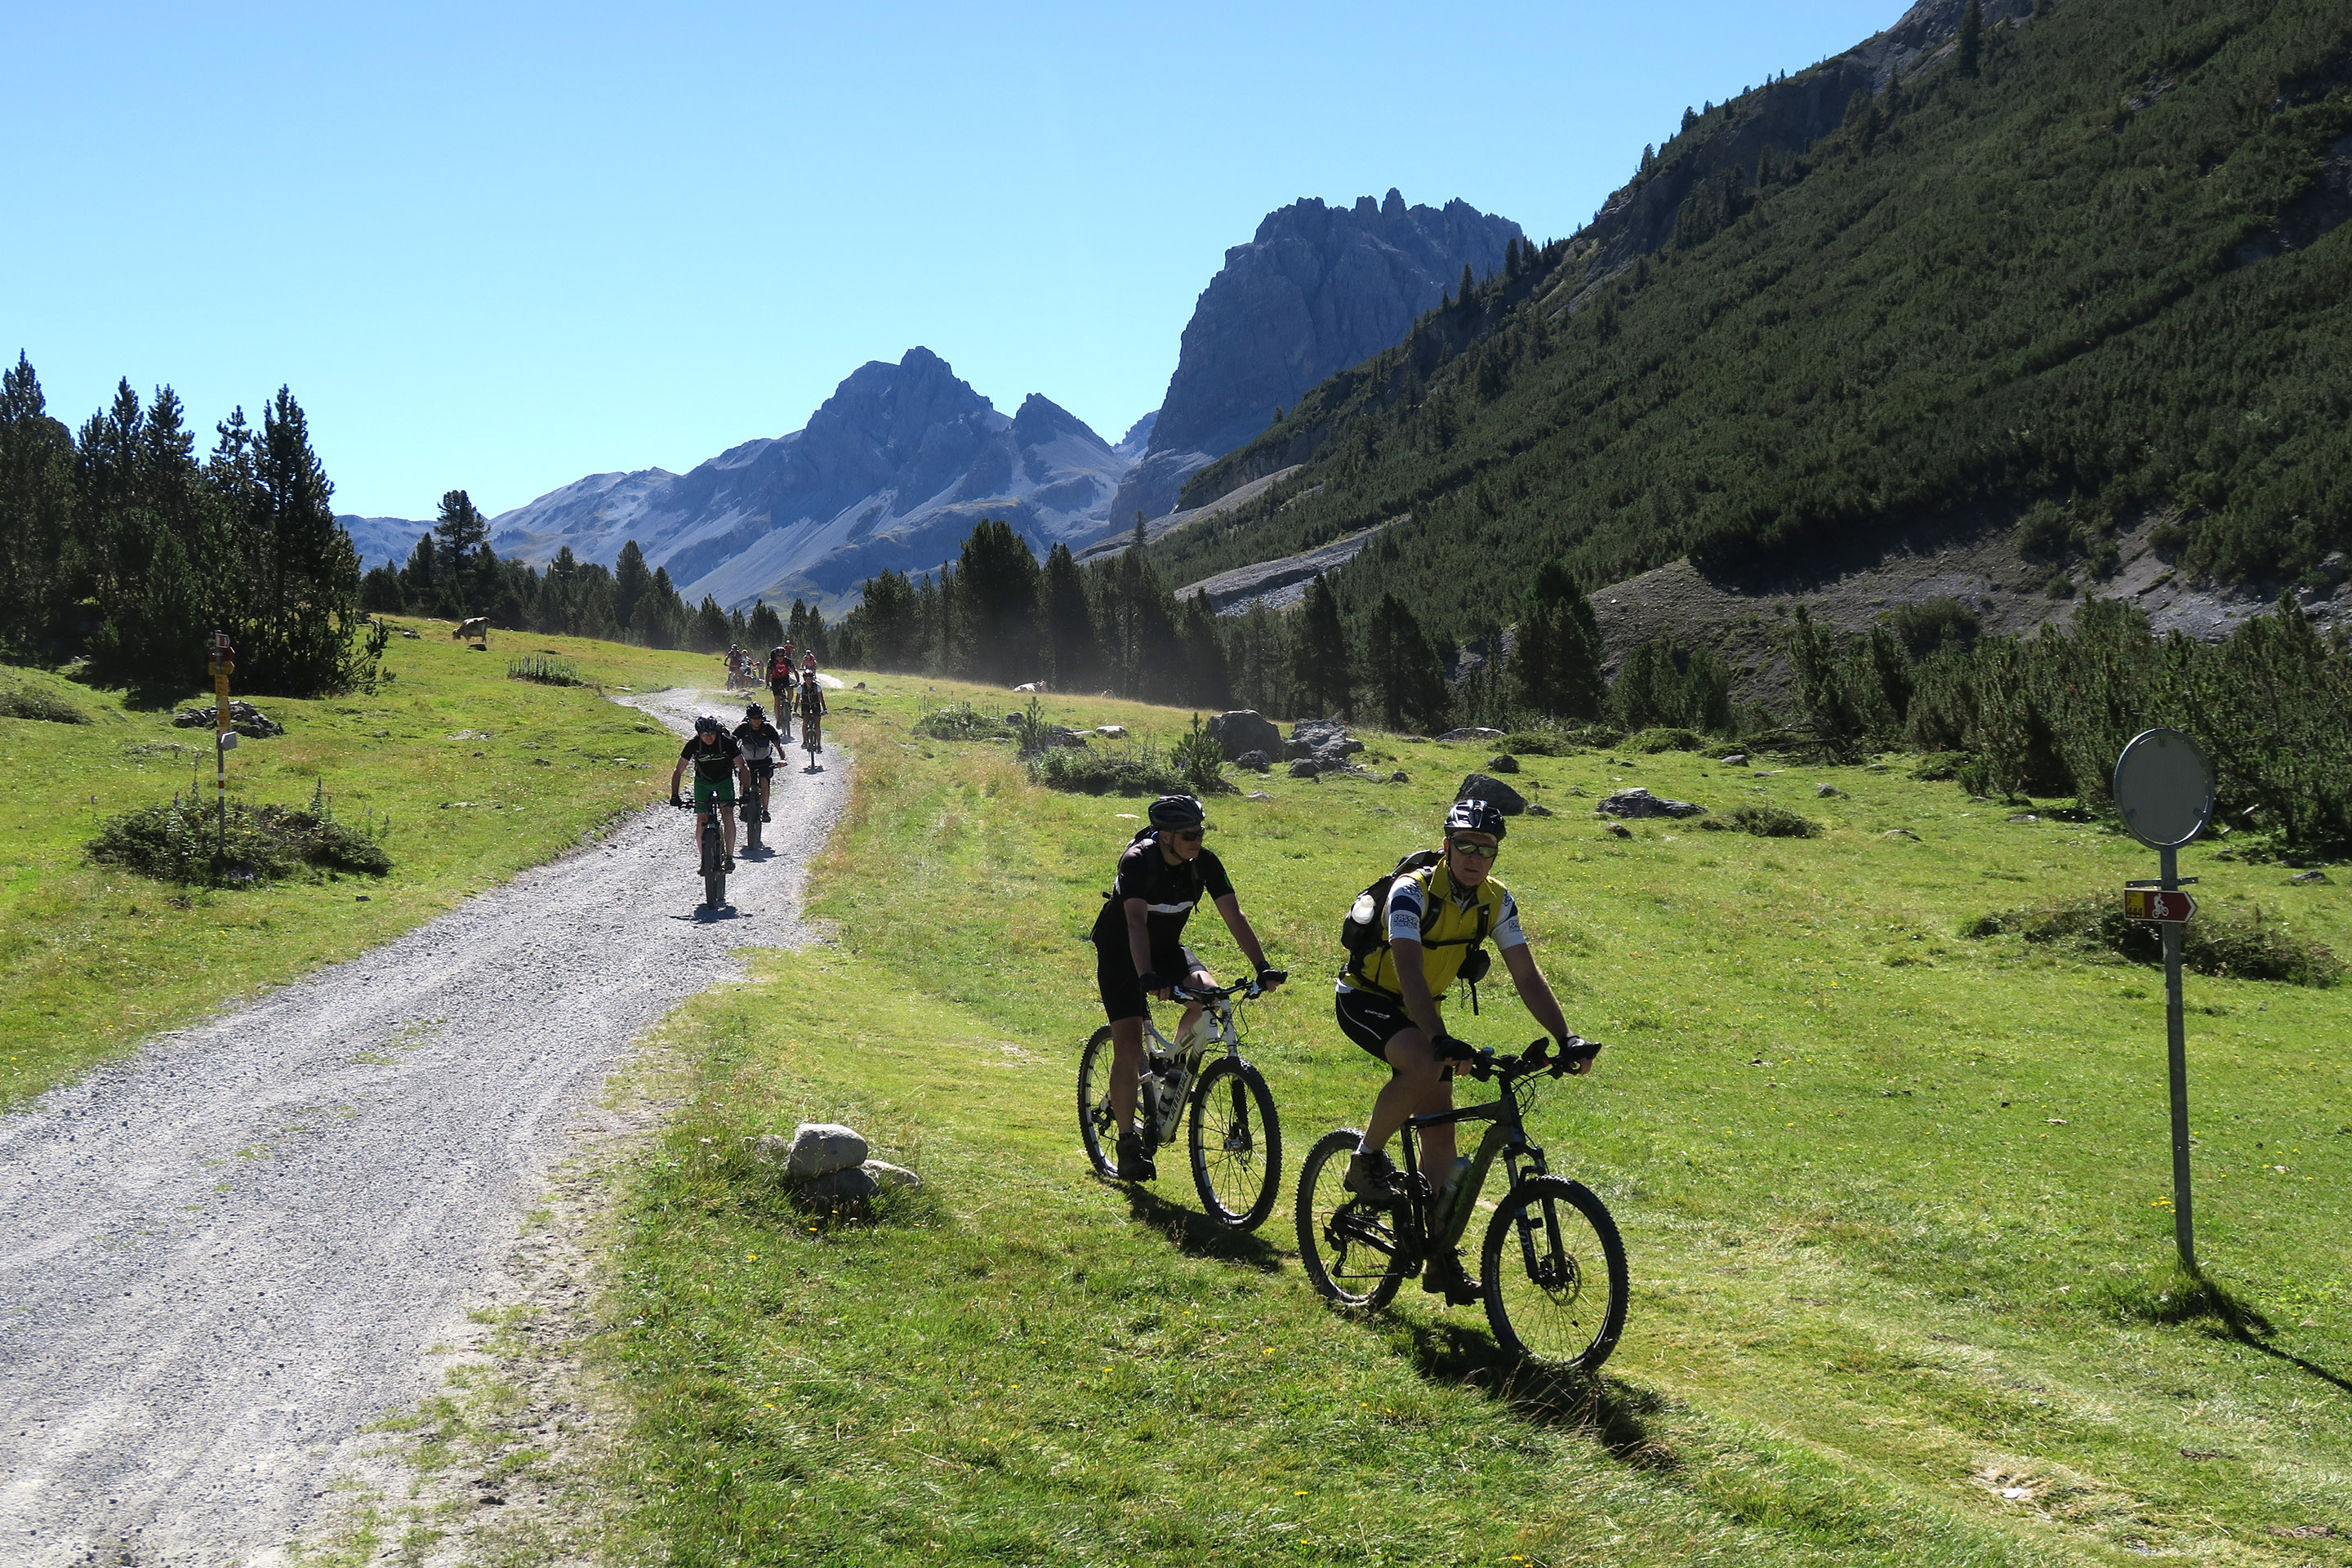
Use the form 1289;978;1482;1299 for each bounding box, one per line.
492;348;1127;609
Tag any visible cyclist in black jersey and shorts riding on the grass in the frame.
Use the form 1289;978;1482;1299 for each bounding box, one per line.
1091;795;1284;1183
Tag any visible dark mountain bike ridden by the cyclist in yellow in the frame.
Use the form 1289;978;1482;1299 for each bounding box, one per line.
1298;1036;1628;1373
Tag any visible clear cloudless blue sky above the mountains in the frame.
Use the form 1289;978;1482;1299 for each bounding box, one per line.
0;0;1903;517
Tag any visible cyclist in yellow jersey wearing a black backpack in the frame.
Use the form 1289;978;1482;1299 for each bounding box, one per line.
1336;800;1590;1305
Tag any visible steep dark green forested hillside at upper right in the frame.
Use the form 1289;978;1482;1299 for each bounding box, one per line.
1155;0;2352;637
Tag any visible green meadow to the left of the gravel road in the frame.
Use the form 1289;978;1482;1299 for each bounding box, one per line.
0;621;710;1105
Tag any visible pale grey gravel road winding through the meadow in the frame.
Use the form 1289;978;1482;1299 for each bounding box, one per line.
0;693;847;1568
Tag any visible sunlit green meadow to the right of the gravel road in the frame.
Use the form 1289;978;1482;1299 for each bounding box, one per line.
609;677;2352;1566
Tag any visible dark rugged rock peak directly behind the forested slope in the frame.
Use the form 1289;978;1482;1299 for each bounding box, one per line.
1110;188;1521;529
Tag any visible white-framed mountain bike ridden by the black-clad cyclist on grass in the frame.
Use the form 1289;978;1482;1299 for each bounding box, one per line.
1077;978;1282;1229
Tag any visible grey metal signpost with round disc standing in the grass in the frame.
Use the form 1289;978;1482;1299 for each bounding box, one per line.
2114;728;2213;1274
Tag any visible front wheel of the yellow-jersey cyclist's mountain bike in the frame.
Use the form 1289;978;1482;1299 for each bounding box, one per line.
1480;1175;1628;1373
